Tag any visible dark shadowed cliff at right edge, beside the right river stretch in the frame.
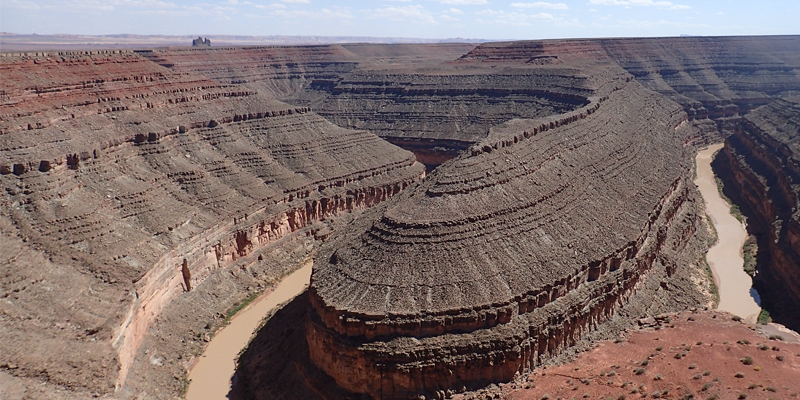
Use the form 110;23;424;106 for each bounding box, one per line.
713;97;800;330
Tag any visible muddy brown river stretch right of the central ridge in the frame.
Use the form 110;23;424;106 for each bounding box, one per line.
694;144;761;322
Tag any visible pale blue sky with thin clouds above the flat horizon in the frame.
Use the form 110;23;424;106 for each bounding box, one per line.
0;0;800;40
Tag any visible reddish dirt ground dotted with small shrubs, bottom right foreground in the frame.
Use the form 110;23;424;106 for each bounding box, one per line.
494;311;800;400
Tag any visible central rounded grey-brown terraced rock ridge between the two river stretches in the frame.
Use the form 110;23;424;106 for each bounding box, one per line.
306;81;704;399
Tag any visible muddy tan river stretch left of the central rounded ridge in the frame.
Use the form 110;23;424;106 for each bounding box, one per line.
186;261;313;400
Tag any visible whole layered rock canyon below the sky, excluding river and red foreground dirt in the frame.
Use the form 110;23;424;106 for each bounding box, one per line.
0;36;800;399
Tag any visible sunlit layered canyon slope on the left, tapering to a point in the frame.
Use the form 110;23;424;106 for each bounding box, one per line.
0;50;424;394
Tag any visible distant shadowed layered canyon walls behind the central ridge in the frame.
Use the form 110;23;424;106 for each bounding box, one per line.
285;36;800;155
